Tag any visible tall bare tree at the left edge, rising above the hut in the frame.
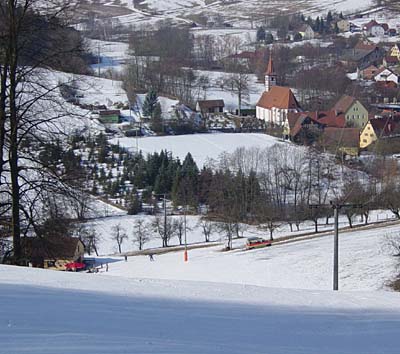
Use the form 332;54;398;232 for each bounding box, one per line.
0;0;87;264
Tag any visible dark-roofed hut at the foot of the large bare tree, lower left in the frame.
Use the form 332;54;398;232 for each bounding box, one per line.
21;236;85;270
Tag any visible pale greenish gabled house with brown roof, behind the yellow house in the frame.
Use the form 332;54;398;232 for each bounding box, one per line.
332;95;368;129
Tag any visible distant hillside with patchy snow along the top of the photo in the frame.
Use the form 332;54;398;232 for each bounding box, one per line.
74;0;378;27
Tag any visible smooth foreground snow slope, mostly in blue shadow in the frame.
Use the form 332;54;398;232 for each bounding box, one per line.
0;266;400;354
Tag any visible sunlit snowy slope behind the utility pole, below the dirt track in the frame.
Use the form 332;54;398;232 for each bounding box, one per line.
98;217;400;291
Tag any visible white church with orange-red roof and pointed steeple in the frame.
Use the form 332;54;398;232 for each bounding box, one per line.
256;55;301;126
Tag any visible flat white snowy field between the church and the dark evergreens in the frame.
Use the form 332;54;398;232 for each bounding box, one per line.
111;133;283;167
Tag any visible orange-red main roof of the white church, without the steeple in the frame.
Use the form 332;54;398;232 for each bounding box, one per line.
257;86;300;109
